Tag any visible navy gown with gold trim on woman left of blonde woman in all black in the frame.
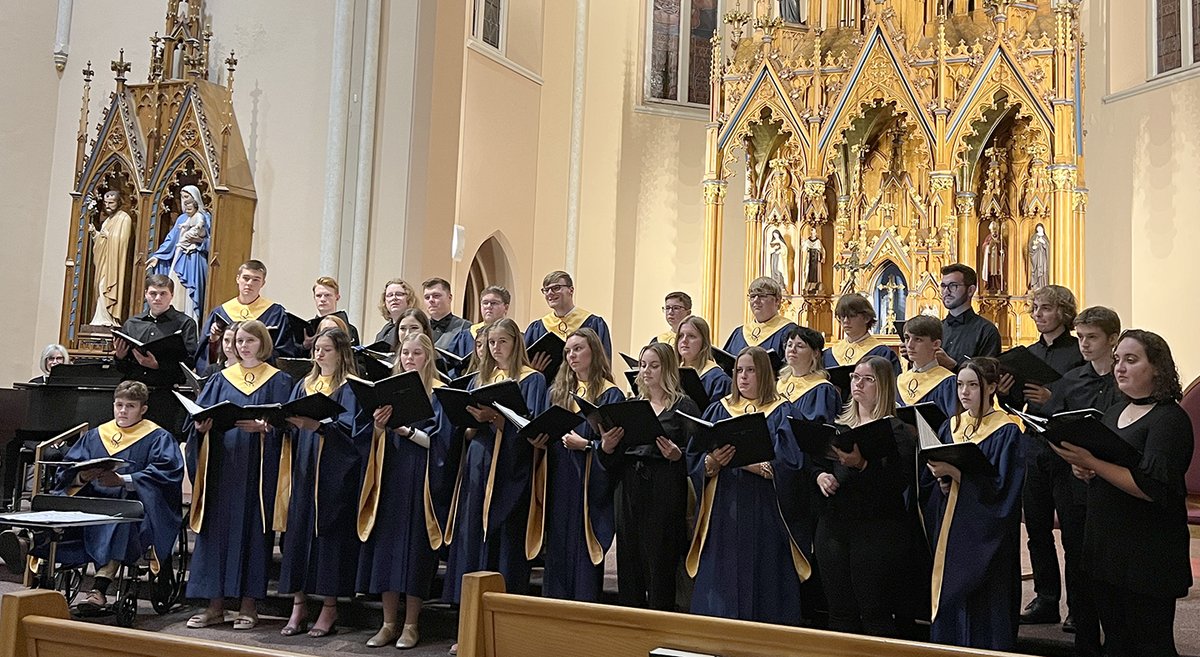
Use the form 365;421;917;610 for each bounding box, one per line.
526;381;625;602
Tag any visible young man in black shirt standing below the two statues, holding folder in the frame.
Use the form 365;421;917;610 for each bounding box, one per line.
113;273;198;433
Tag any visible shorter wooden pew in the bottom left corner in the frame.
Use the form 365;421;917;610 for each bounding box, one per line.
0;590;301;657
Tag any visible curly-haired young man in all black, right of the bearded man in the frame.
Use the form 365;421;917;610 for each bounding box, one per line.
1000;285;1084;629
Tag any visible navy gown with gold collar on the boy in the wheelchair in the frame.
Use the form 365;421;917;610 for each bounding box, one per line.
56;420;184;567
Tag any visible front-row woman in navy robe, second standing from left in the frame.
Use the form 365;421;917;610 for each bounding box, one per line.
275;330;371;637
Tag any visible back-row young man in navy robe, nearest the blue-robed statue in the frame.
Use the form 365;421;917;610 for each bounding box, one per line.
196;260;302;372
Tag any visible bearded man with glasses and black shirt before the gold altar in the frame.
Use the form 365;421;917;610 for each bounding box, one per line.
937;263;1000;372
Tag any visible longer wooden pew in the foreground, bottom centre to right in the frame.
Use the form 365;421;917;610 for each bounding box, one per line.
458;573;1007;657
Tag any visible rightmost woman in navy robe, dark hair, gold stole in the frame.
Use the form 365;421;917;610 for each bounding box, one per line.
922;357;1025;651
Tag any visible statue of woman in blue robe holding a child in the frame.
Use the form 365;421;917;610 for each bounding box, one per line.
146;185;212;325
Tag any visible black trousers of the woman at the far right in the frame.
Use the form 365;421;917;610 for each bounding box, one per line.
1091;579;1178;657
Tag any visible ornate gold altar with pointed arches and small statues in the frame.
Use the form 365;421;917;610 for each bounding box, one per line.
703;0;1087;344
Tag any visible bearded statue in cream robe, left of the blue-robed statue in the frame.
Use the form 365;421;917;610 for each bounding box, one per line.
88;189;133;326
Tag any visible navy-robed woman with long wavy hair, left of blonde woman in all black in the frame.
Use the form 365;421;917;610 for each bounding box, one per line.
526;329;625;602
